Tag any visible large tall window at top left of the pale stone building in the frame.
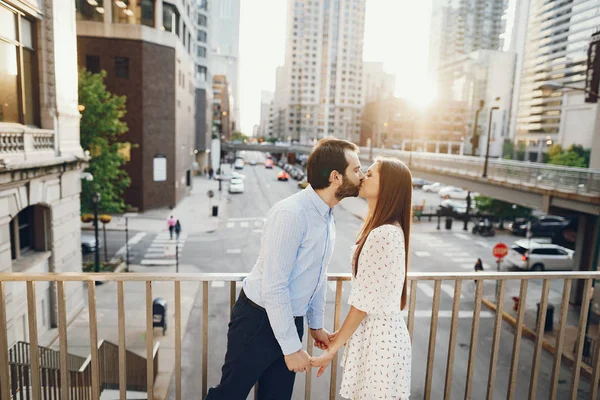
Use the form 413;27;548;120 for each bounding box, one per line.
0;5;39;125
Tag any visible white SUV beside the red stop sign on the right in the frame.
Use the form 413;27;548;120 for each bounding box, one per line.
506;239;575;272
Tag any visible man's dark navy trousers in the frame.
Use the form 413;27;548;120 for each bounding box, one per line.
205;290;304;400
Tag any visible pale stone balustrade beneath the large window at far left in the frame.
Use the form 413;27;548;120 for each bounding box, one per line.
0;124;55;164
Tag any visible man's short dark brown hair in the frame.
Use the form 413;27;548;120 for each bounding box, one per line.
306;138;358;190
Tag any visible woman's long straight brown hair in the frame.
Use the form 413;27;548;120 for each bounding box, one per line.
353;158;412;310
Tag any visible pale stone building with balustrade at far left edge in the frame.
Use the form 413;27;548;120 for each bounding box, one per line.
0;0;85;345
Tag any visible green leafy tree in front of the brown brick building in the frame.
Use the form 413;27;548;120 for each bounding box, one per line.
79;69;131;212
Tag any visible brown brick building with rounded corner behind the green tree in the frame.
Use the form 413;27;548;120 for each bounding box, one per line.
75;0;197;210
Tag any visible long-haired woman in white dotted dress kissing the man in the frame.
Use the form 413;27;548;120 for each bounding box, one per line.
311;158;412;400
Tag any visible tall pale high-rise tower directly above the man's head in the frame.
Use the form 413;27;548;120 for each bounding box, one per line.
282;0;366;143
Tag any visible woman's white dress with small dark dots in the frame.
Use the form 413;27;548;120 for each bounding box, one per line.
340;225;411;400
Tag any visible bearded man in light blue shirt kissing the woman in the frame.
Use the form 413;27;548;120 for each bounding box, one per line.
206;139;364;400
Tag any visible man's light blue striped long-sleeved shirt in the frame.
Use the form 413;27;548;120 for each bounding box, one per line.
243;186;335;355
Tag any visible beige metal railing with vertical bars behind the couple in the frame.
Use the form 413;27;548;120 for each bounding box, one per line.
0;272;600;400
